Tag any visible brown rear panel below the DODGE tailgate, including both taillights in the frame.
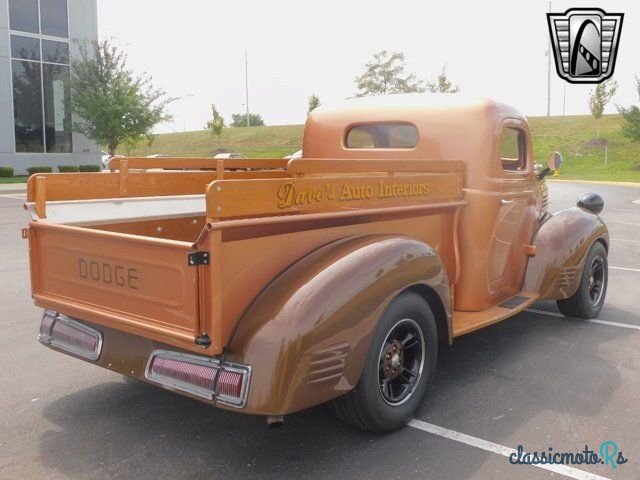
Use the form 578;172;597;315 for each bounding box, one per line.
38;310;252;414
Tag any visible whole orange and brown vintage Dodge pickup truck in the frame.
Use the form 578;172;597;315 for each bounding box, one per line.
24;95;609;431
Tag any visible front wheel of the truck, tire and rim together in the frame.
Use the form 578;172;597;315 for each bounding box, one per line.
556;242;609;318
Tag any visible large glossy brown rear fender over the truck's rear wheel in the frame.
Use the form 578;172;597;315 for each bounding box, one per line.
227;235;451;415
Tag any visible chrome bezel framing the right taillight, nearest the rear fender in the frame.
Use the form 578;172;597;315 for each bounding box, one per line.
145;350;251;408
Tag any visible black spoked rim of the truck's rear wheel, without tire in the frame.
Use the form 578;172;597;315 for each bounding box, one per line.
378;318;425;405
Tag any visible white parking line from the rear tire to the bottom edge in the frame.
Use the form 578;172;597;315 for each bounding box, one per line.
409;418;610;480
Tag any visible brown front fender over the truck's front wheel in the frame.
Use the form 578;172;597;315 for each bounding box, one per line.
524;207;609;300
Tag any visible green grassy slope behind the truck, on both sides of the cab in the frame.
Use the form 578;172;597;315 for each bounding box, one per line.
118;115;640;182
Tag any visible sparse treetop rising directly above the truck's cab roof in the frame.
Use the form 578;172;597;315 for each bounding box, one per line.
355;50;424;97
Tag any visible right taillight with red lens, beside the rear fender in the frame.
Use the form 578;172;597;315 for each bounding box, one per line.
145;350;251;407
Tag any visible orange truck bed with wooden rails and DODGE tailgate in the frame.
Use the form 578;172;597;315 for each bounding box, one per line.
26;159;464;355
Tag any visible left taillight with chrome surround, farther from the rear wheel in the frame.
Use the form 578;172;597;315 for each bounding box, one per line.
38;310;102;360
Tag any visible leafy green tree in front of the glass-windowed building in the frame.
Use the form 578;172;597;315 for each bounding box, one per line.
70;40;175;155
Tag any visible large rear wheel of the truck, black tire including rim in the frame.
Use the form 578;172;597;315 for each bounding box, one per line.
329;292;438;433
